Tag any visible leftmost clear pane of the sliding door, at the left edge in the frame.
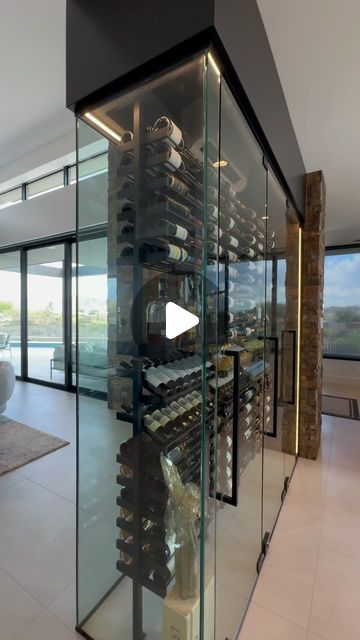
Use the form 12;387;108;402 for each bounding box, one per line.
0;251;21;375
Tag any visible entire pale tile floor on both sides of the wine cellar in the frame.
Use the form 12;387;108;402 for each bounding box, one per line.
0;382;360;640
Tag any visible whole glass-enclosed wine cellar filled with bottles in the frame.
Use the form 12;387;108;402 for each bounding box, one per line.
77;52;300;640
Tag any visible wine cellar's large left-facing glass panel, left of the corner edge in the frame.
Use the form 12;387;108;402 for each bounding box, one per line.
78;57;211;640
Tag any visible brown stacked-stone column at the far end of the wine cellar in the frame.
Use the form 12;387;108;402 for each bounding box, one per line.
299;171;326;460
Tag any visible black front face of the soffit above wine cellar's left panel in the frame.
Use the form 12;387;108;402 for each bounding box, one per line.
66;0;214;107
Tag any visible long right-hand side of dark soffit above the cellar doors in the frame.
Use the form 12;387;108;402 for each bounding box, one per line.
215;0;305;211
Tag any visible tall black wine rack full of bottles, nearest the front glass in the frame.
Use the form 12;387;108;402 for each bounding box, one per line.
109;100;216;640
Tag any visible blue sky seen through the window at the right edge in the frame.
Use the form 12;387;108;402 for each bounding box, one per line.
324;253;360;308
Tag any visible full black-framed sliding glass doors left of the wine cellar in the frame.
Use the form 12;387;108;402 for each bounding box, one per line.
0;237;76;390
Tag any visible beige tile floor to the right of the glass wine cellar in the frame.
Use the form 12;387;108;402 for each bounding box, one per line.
239;385;360;640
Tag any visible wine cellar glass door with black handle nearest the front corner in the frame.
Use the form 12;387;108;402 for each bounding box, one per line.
214;81;266;640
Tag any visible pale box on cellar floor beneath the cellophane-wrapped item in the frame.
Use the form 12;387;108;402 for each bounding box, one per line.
162;576;214;640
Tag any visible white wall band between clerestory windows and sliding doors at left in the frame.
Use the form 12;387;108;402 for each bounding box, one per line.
0;185;76;246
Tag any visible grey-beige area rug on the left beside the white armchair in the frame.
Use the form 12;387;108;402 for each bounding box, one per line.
0;416;69;476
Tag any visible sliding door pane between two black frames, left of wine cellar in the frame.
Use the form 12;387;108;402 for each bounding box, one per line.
27;244;65;384
